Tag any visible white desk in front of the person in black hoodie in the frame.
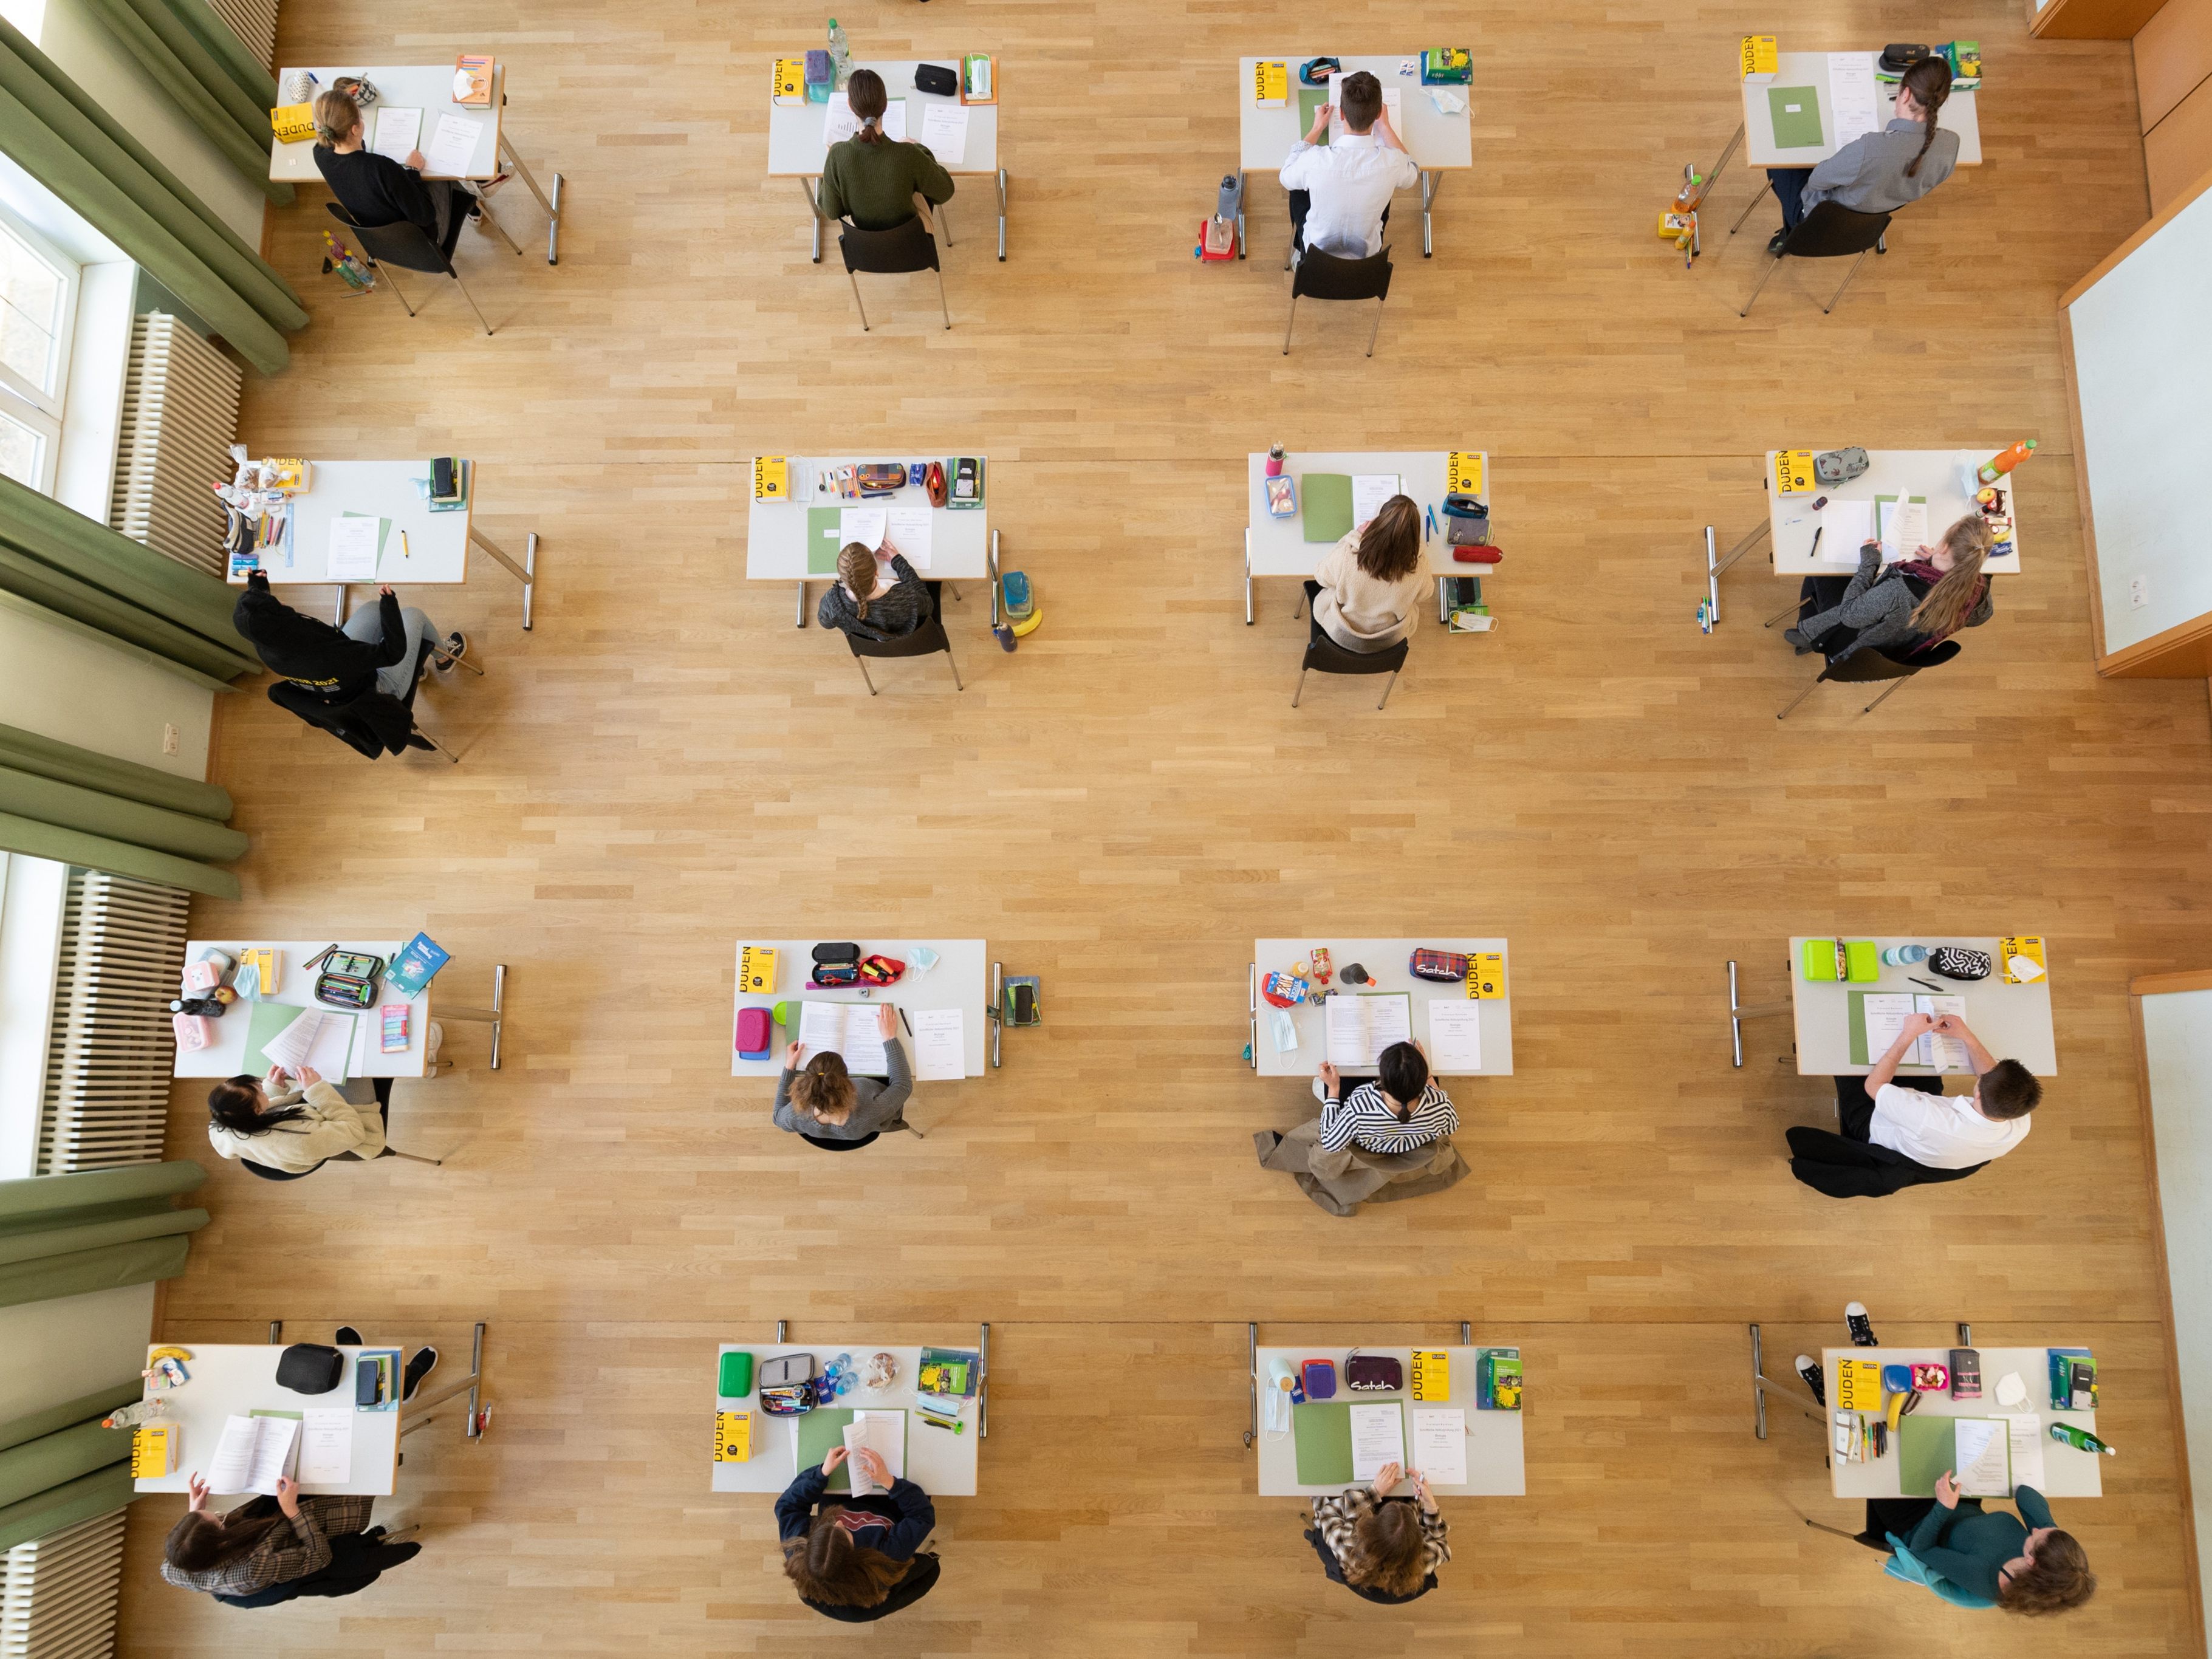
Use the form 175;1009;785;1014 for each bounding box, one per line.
230;458;538;628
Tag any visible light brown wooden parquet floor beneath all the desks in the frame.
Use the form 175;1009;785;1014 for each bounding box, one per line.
124;0;2212;1659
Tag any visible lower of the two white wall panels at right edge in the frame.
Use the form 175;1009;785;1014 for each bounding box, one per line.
2143;991;2212;1619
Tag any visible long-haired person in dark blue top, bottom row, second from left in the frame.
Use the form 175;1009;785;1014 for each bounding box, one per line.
776;1446;938;1624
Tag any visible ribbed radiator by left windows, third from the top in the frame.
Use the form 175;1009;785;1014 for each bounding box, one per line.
38;869;190;1175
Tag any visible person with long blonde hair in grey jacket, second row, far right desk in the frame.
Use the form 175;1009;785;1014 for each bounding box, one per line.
1783;513;1995;663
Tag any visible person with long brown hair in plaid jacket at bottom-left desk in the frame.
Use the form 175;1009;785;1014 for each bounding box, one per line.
162;1473;422;1608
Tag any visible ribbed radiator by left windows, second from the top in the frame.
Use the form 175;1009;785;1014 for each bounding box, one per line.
108;312;245;575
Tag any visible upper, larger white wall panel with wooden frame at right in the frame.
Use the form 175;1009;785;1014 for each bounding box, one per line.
2061;193;2212;652
